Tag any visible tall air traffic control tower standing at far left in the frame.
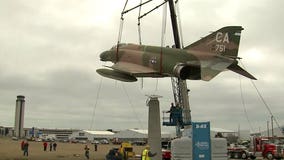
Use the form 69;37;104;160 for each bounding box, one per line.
14;95;25;138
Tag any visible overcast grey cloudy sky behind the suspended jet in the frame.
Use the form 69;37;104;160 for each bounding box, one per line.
0;0;284;131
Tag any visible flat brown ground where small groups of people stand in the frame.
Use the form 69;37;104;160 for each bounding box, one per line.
0;137;143;160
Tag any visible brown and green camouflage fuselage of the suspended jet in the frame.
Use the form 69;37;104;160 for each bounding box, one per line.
101;44;199;74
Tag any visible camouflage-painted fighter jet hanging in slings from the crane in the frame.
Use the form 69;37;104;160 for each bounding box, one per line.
97;26;256;82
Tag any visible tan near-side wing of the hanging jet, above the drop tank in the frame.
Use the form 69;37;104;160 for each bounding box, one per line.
110;62;159;77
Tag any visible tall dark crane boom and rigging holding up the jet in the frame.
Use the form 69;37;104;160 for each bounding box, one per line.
117;0;191;137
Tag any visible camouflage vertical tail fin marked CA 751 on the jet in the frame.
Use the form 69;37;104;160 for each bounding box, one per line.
184;26;243;59
